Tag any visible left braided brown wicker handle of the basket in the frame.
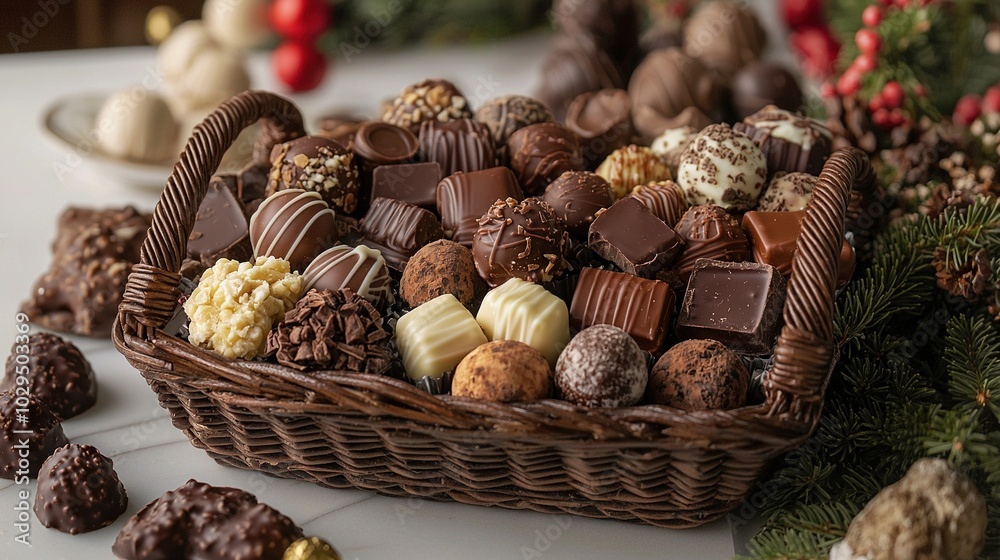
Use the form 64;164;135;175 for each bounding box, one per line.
118;91;304;338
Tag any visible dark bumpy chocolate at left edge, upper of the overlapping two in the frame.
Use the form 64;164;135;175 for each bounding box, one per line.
0;332;97;420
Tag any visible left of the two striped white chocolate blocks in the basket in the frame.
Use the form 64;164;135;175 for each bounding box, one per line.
396;294;488;380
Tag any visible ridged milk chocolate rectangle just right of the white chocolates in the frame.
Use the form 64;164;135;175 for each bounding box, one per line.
569;268;677;355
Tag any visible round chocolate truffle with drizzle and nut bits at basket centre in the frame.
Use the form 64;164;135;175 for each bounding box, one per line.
472;198;569;287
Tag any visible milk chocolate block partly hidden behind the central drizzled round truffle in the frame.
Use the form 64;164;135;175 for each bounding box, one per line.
437;167;524;248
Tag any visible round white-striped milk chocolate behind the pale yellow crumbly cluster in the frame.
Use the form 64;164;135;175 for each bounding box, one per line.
250;189;338;272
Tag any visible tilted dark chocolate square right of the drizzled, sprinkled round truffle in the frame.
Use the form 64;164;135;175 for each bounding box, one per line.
588;197;684;278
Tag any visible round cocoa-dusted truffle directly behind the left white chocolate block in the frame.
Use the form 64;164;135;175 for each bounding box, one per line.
399;239;478;307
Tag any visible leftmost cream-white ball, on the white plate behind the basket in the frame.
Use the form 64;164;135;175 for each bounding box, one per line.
94;87;180;162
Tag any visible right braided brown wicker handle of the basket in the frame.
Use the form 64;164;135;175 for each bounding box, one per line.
764;148;876;424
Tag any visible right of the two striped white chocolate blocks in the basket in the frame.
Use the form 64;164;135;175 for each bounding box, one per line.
476;278;569;366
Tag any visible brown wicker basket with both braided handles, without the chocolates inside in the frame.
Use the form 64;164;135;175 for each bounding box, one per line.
114;92;874;527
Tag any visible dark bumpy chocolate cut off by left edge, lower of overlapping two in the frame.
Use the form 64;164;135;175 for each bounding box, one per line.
0;391;69;484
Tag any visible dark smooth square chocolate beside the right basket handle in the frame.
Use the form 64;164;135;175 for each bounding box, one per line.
676;259;787;355
